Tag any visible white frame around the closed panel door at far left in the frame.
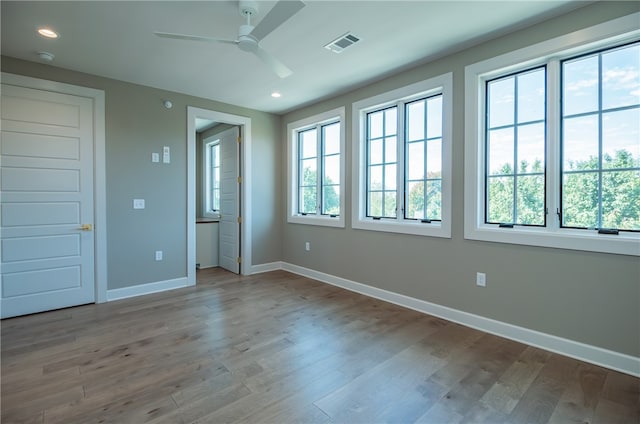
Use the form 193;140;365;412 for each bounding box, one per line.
2;72;107;303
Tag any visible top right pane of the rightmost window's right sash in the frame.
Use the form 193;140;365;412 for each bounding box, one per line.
602;44;640;109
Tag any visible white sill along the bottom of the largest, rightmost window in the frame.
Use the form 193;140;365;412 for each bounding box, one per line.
464;225;640;256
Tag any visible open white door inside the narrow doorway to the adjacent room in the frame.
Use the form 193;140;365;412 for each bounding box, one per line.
219;127;240;274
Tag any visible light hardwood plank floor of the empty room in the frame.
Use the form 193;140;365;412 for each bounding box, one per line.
1;268;640;424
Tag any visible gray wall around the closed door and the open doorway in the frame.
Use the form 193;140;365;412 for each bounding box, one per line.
2;57;282;289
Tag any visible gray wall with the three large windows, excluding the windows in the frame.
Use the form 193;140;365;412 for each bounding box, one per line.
282;2;640;356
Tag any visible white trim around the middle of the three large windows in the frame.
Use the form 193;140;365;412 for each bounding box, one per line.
351;72;453;238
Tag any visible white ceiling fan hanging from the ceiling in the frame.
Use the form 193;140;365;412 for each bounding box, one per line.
154;0;305;78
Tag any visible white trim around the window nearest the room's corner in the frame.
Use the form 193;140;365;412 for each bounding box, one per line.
287;107;346;228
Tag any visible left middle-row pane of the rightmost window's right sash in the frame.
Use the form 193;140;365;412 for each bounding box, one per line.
562;115;598;171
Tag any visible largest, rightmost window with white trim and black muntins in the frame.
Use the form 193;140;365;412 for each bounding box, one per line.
465;14;640;255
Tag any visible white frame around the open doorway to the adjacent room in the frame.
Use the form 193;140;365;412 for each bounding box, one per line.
187;106;251;286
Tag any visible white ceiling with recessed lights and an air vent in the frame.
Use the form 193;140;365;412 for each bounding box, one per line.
1;0;589;113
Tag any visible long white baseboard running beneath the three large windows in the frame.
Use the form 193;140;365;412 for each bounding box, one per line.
276;262;640;377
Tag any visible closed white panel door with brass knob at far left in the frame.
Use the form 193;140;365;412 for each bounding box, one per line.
0;84;95;318
